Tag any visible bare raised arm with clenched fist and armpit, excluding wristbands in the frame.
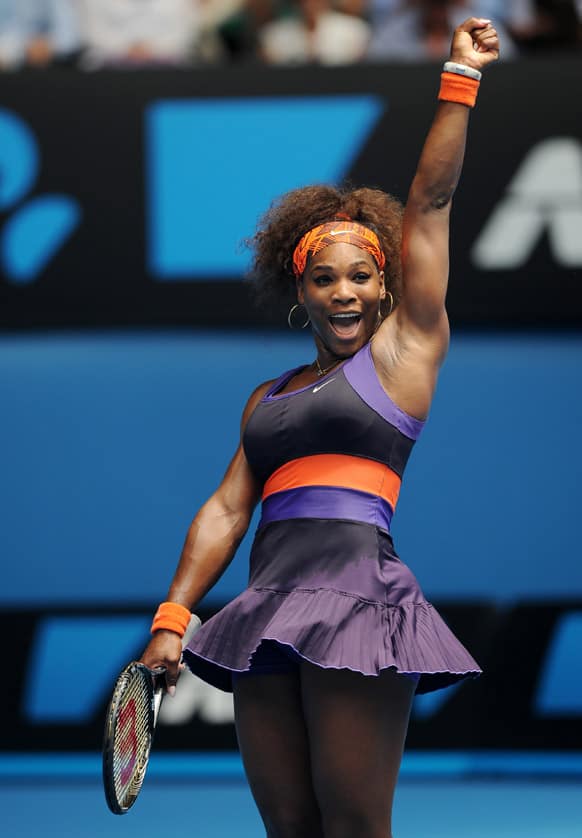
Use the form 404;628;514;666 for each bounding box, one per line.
372;18;499;418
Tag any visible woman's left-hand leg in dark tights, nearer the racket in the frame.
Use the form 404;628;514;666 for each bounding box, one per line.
234;668;323;838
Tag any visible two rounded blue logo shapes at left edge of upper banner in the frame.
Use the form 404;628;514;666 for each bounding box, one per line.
0;108;81;285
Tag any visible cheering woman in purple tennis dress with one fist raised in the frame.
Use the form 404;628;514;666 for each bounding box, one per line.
143;18;498;838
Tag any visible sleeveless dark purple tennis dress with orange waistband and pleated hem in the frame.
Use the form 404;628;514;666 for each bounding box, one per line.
184;344;480;693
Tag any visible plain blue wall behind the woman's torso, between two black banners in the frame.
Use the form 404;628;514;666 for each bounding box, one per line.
0;331;582;605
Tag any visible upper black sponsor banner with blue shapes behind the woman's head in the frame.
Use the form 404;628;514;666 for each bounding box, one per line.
0;58;582;328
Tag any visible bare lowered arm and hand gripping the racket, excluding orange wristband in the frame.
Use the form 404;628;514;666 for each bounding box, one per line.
141;382;271;688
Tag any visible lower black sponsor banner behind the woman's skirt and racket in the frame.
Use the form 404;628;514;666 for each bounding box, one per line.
8;601;582;753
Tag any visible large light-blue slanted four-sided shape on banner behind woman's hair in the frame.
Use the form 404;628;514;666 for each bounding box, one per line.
146;95;385;280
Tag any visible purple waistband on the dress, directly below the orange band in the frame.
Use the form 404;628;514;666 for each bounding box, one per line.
259;486;392;532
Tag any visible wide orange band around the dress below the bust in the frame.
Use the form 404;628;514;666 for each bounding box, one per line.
263;454;402;509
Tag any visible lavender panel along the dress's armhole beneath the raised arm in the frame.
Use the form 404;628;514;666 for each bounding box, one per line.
343;343;425;440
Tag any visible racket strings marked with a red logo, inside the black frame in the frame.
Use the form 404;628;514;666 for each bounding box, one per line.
112;669;152;807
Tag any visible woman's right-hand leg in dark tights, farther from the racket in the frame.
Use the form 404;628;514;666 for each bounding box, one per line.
301;664;415;838
